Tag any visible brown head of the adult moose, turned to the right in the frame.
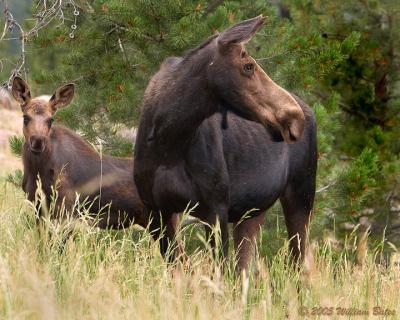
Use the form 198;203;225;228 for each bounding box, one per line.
207;16;305;142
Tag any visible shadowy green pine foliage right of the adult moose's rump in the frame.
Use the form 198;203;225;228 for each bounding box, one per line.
284;0;400;242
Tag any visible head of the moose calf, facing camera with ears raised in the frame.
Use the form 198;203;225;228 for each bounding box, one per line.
12;77;74;155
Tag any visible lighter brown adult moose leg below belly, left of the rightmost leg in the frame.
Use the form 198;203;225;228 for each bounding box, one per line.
233;212;265;273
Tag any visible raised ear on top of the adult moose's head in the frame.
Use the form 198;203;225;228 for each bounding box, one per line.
218;15;266;52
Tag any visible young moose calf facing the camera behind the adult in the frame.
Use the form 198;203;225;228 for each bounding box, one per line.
12;77;148;228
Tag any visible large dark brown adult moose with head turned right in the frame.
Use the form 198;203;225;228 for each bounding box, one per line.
134;16;317;269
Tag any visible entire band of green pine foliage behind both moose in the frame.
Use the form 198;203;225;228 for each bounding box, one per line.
2;0;400;245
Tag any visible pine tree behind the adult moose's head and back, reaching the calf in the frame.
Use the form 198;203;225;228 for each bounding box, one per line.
31;0;357;155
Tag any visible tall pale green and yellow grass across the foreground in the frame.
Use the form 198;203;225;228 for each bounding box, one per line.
0;182;400;319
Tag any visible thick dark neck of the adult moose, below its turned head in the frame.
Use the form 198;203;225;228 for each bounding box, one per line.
153;45;218;151
